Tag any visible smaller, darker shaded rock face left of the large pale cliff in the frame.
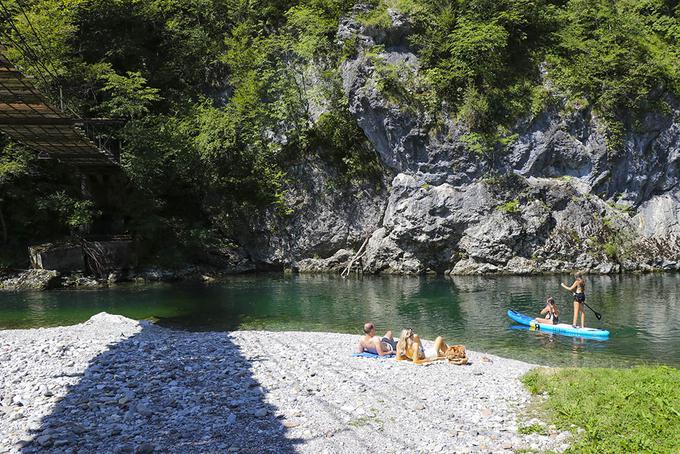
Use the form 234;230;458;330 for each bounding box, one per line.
238;159;386;270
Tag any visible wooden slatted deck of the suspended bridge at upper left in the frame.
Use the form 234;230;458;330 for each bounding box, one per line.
0;45;118;167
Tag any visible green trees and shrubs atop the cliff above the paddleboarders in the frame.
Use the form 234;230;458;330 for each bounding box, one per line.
383;0;680;139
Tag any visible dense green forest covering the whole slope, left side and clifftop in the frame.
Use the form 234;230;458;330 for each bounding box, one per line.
0;0;680;266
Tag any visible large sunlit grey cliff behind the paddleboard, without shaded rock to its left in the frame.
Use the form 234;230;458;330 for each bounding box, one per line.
339;7;680;274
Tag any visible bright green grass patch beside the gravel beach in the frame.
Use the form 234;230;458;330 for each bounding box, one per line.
522;366;680;453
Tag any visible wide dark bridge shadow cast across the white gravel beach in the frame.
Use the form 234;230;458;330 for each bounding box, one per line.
22;326;299;454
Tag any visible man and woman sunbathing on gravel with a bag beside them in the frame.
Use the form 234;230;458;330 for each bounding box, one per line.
357;322;467;364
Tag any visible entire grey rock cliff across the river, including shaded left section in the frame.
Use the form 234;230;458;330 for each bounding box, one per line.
241;7;680;274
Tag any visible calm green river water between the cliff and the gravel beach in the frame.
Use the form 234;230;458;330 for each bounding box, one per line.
0;274;680;367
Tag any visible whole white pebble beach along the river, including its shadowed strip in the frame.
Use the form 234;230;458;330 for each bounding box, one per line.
0;313;570;453
